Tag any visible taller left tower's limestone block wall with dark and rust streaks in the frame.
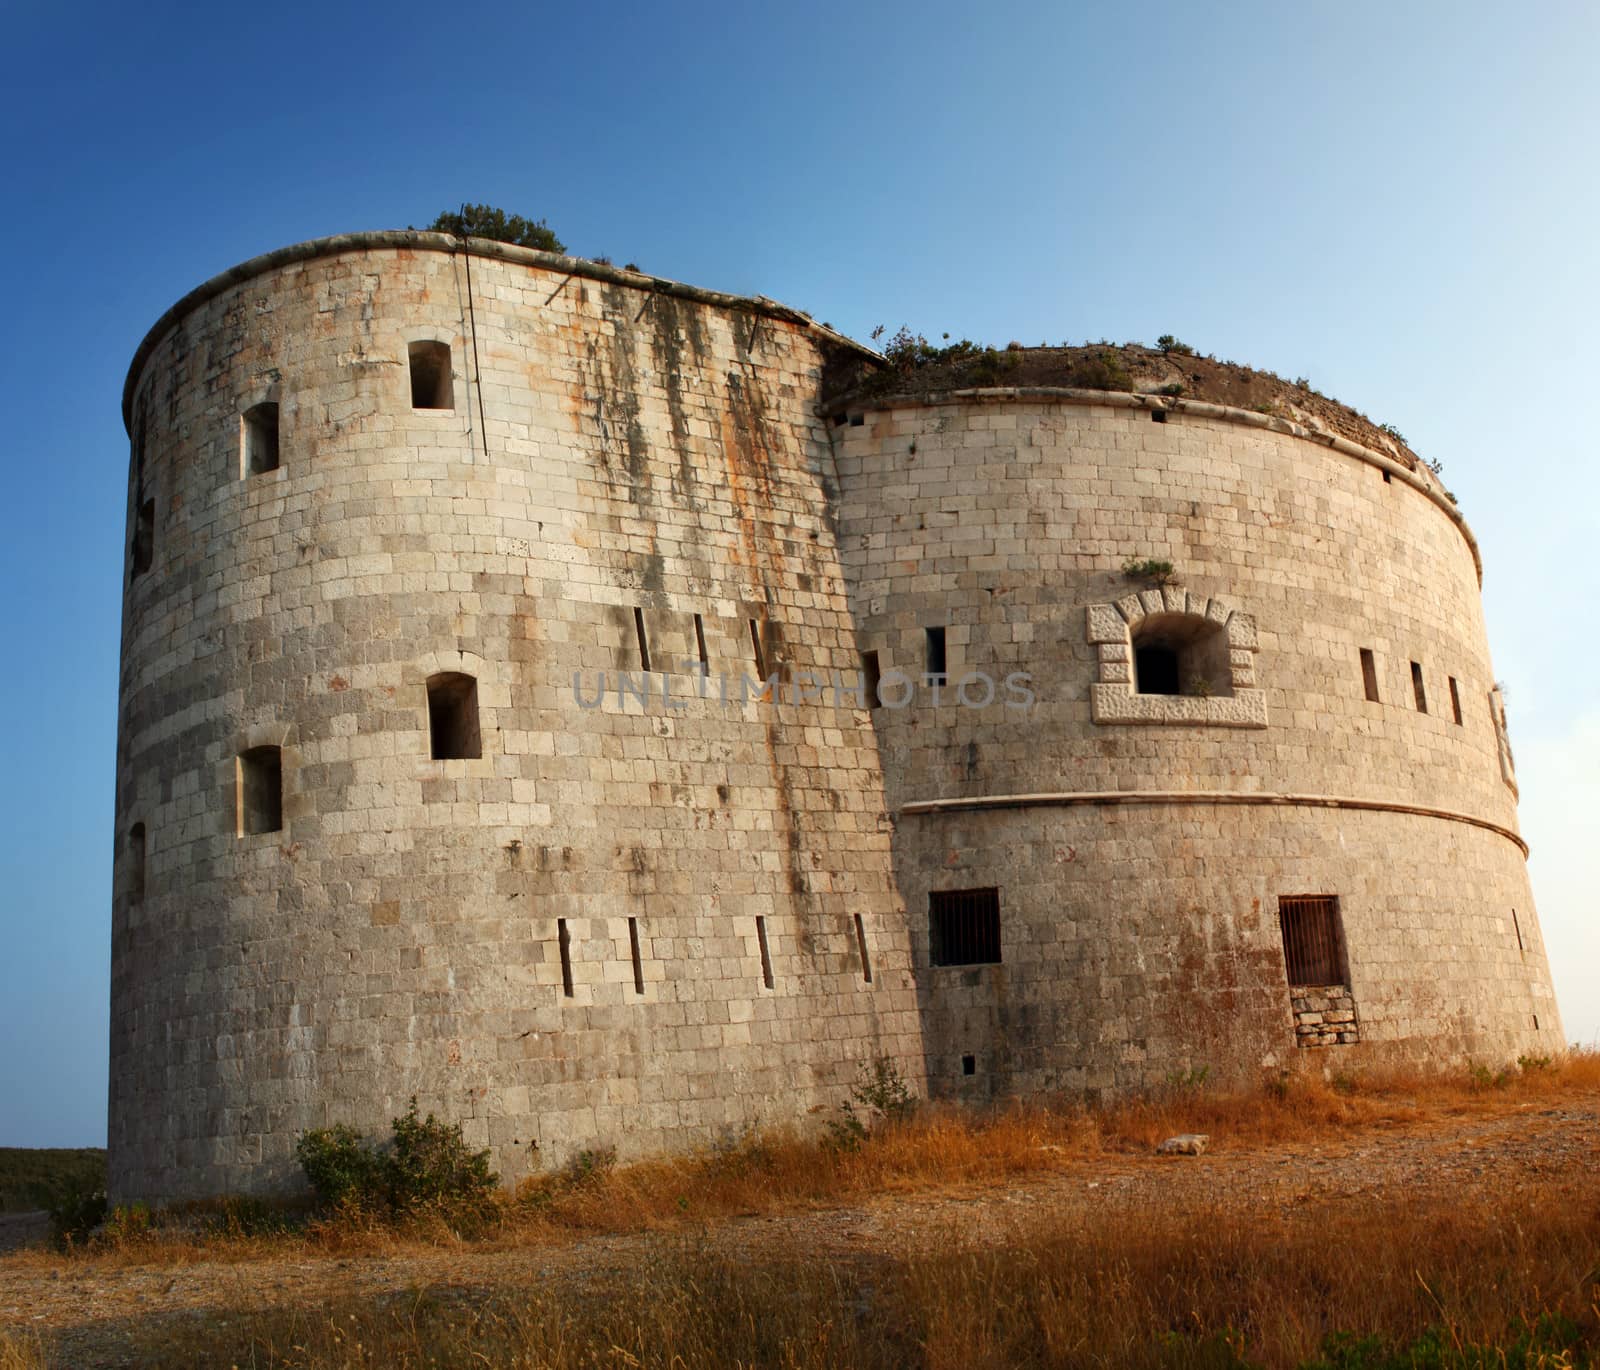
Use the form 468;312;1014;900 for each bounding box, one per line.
110;235;922;1200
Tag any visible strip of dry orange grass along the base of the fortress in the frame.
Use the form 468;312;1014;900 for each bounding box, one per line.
12;1050;1600;1268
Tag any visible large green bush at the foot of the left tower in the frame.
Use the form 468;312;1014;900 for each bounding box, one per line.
294;1096;499;1212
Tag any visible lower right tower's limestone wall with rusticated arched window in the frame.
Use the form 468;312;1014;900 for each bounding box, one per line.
830;391;1562;1096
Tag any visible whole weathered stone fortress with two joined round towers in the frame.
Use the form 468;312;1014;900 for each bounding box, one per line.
109;232;1563;1202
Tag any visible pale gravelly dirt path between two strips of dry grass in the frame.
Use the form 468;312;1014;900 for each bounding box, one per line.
0;1095;1600;1367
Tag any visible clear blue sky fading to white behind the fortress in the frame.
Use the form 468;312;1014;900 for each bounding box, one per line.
0;0;1600;1146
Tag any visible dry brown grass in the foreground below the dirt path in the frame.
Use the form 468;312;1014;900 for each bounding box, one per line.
90;1175;1600;1370
